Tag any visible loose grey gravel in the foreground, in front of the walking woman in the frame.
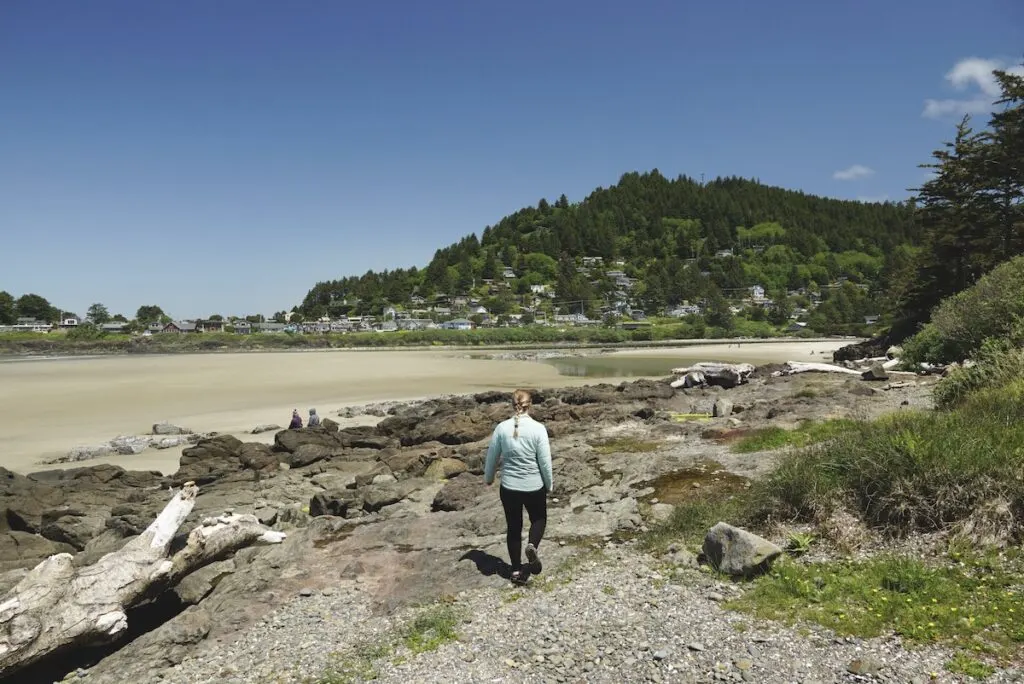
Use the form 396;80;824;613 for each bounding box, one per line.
155;545;1024;684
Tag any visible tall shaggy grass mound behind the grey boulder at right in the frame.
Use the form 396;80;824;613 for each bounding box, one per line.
753;380;1024;544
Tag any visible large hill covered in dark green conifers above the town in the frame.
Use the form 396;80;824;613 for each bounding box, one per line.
299;170;918;317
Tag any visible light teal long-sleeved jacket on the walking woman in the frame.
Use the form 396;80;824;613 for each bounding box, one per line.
483;415;553;491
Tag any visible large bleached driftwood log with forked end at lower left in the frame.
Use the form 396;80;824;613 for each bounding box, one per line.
0;482;285;674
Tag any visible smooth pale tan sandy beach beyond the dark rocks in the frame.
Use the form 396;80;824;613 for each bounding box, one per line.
0;341;848;472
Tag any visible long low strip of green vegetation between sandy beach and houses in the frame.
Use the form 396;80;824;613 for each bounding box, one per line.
0;325;839;356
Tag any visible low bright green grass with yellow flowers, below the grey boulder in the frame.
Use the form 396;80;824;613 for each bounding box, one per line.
727;553;1024;674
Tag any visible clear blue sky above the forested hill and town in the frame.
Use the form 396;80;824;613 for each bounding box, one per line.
0;0;1024;317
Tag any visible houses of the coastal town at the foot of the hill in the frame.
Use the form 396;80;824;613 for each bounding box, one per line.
0;250;879;336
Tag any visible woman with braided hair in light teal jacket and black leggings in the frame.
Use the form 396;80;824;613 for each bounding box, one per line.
483;389;552;584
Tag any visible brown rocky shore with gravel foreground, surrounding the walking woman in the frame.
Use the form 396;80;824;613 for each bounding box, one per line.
6;368;1011;684
